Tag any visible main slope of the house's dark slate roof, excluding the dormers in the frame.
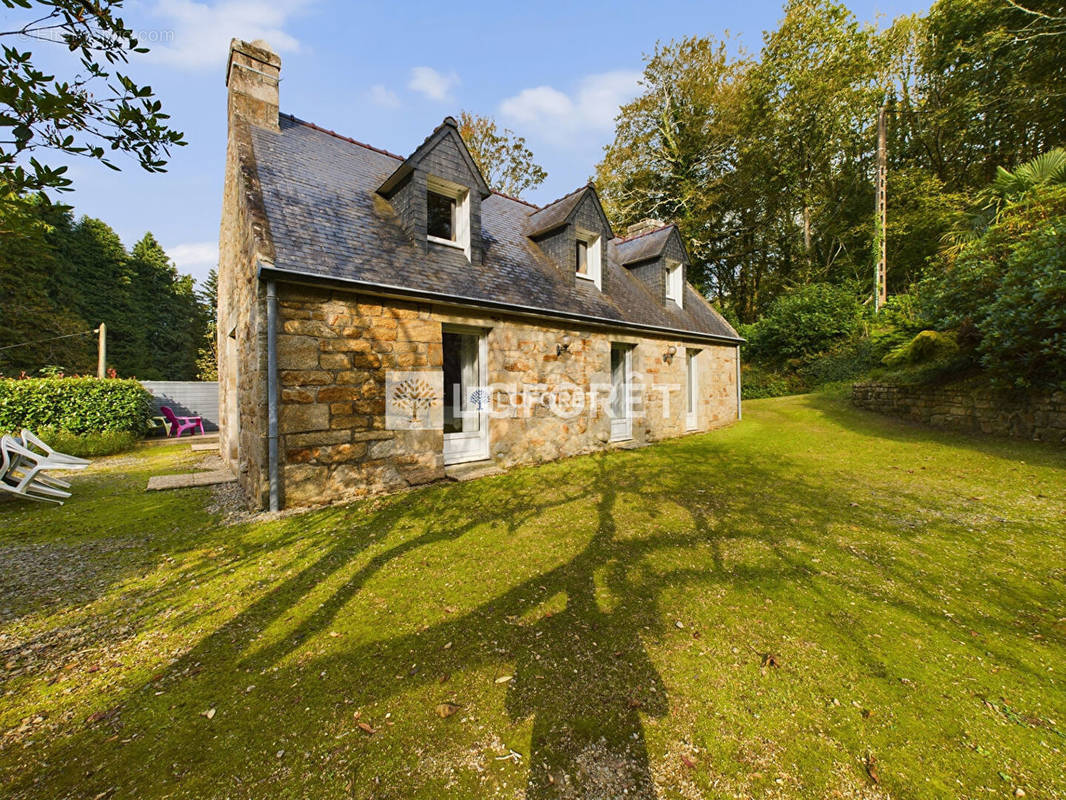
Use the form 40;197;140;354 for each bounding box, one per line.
251;114;740;341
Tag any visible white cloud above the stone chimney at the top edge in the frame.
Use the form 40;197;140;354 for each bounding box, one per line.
141;0;312;69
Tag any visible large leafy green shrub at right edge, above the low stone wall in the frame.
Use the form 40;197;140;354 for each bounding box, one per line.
923;186;1066;387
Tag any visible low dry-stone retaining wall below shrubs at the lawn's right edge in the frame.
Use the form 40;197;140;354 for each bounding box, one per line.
852;383;1066;444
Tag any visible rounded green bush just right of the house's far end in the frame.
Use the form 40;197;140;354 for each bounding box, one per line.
744;284;862;364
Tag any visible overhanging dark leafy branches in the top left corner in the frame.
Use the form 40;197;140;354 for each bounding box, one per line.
0;0;185;216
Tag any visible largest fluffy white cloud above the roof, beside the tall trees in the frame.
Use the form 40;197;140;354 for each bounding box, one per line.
500;69;641;141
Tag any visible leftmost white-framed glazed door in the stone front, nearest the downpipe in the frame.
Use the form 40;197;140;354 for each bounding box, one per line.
441;327;488;464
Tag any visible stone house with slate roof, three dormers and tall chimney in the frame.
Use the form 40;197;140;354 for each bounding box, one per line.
219;39;742;508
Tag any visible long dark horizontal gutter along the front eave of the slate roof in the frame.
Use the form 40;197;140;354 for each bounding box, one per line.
259;263;746;347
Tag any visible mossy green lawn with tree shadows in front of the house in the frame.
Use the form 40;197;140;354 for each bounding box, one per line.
0;396;1066;800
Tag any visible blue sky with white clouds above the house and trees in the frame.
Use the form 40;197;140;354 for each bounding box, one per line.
0;0;928;288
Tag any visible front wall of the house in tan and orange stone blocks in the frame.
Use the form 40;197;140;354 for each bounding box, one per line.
277;284;737;507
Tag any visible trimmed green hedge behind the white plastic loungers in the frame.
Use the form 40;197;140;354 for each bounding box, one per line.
0;378;151;434
